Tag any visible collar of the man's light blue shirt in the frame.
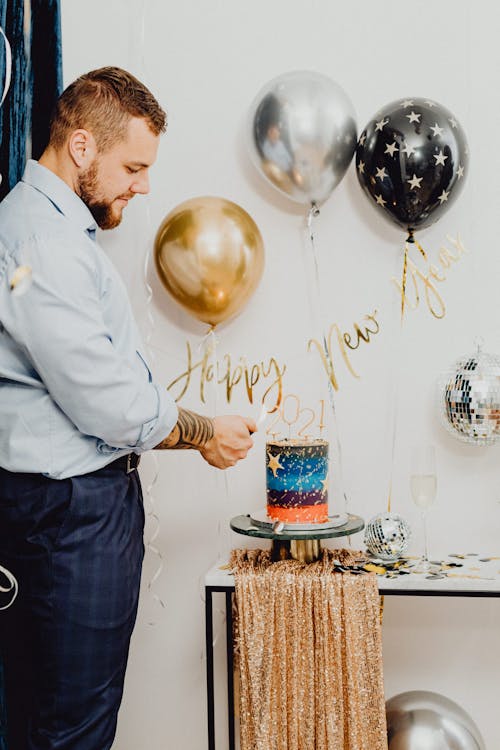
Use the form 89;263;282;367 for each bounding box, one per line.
22;159;97;240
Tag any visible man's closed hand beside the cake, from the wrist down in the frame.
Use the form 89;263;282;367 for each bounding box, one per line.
199;416;257;469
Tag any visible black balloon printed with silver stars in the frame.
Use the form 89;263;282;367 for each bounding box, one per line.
356;98;469;235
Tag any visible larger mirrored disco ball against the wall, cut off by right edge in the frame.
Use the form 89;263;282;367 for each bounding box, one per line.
439;348;500;445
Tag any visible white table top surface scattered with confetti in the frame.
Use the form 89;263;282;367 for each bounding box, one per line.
205;554;500;596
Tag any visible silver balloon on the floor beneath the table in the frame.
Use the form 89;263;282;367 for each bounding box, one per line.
386;690;485;750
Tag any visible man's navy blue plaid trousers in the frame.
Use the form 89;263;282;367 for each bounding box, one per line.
0;465;144;750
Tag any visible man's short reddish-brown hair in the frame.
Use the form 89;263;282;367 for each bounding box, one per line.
50;67;167;152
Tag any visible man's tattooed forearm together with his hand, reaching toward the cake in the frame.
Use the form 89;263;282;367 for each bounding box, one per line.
156;408;257;469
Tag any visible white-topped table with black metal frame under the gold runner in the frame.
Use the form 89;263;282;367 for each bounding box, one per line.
205;553;500;750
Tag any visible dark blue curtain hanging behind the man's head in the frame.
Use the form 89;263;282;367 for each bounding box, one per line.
0;0;62;750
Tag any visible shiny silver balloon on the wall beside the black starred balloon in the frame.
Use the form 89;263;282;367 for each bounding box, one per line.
250;71;357;205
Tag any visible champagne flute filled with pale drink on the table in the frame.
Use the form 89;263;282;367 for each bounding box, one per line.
410;445;437;573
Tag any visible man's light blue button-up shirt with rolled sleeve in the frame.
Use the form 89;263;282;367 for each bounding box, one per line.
0;161;177;479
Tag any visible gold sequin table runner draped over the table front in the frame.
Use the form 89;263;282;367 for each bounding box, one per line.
230;550;387;750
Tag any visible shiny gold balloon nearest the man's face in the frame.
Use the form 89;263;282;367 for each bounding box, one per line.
154;196;264;326
